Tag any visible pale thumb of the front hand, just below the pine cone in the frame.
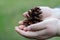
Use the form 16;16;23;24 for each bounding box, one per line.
24;22;47;30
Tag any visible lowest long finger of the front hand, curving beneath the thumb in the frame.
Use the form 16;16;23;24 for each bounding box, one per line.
15;27;46;38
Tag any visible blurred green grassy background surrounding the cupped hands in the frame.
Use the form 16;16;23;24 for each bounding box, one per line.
0;0;60;40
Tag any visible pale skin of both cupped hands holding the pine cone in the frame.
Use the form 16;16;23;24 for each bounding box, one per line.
15;7;60;40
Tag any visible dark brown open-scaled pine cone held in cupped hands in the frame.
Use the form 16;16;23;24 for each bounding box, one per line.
24;7;42;26
